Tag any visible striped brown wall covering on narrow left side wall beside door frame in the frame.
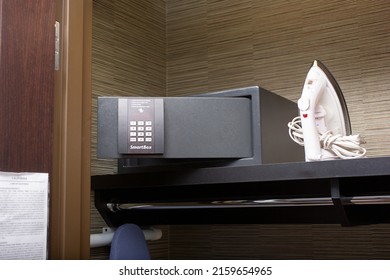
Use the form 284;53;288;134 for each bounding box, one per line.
91;0;169;259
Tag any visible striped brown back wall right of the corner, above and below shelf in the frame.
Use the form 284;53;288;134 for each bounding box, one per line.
167;0;390;259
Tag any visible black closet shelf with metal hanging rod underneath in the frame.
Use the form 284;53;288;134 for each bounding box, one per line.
92;157;390;226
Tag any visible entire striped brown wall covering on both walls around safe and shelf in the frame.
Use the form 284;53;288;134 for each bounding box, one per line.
92;0;390;259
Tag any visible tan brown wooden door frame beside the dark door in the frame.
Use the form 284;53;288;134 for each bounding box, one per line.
49;0;92;259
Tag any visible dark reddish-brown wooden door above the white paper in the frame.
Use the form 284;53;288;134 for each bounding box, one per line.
0;0;55;173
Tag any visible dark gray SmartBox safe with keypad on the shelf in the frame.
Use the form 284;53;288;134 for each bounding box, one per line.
97;86;304;168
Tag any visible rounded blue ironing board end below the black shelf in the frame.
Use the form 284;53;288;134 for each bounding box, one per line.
110;224;150;260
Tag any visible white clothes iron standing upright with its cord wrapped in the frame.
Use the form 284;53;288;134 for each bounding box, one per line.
289;60;366;161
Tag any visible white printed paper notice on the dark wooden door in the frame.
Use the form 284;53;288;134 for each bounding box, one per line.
0;172;49;260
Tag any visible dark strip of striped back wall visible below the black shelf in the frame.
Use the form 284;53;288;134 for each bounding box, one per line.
169;224;390;259
